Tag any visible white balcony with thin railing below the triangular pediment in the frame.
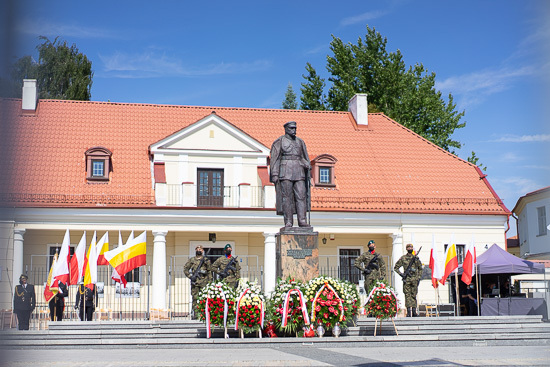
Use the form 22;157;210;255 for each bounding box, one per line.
155;183;275;208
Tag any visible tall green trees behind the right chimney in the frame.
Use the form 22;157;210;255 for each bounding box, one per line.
301;26;466;153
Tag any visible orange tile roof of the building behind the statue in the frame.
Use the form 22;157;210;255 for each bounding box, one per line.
0;99;509;215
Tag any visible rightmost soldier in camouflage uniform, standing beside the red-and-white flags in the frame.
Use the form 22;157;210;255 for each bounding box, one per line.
393;243;422;317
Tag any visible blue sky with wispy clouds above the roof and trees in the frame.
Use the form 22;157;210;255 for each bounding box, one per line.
4;0;550;235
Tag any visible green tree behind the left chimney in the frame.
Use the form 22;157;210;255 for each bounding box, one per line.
1;36;94;101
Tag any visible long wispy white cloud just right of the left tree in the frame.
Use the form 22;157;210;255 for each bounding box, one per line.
99;51;271;78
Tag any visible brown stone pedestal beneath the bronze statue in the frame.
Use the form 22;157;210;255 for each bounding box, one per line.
276;227;319;282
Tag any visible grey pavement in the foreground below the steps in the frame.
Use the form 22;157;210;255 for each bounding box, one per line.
2;344;550;367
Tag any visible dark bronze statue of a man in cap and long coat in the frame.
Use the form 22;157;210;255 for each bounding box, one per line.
269;121;311;227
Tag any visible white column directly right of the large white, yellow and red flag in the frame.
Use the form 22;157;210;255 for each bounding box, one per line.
151;230;168;308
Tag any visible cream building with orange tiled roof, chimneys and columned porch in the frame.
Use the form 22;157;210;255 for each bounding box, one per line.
0;81;510;315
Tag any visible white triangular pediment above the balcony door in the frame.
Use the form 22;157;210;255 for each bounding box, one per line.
151;113;269;157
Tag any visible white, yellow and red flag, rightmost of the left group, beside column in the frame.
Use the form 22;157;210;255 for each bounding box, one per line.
105;232;147;274
